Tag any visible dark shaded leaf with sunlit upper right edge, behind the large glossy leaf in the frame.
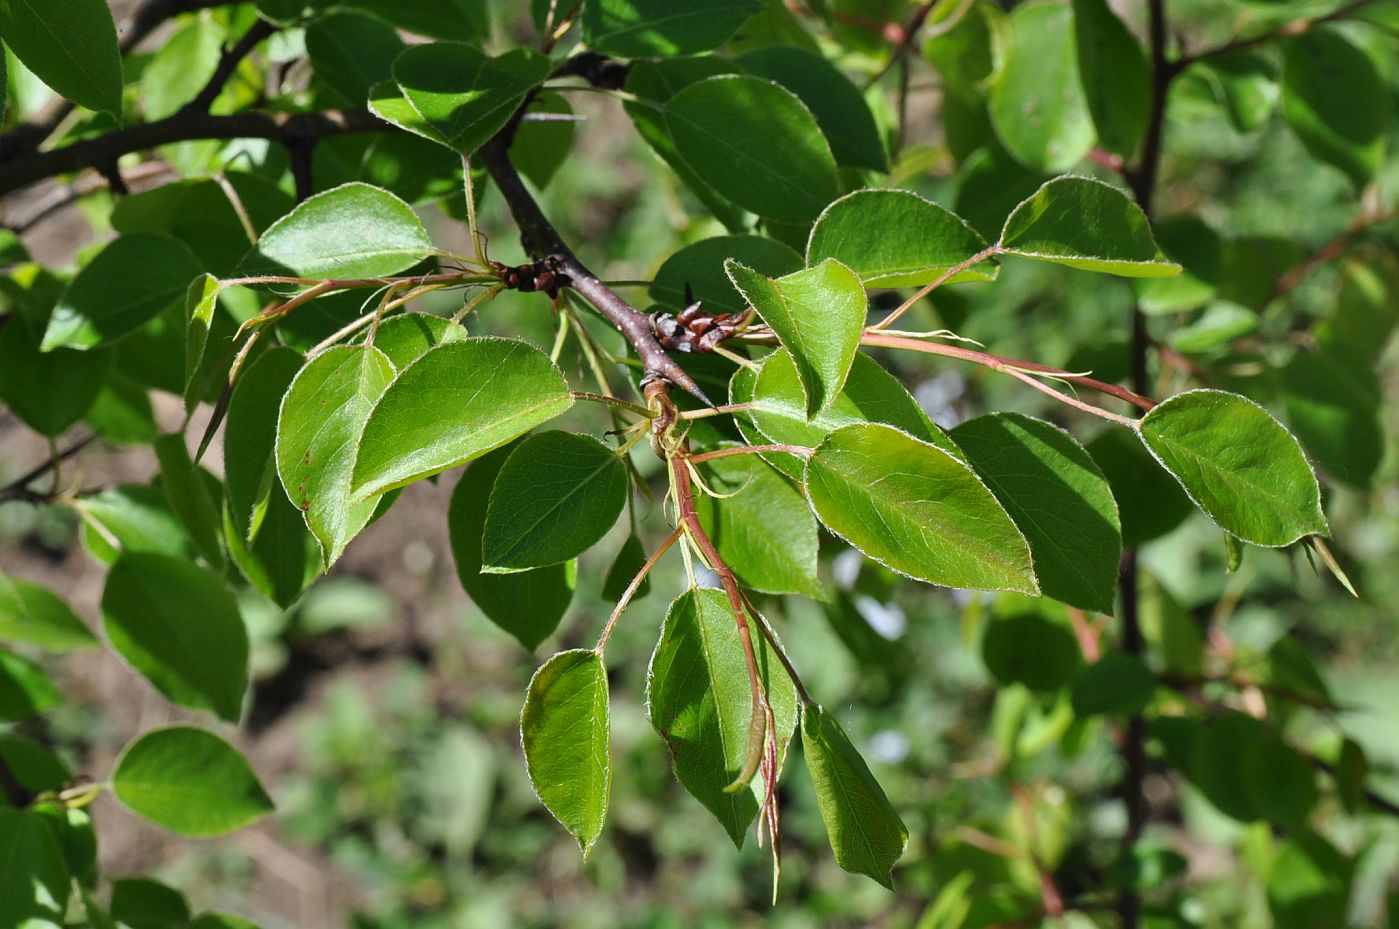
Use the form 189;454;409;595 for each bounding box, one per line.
951;413;1122;614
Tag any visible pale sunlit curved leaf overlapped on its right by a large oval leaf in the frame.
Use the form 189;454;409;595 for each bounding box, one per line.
276;346;393;568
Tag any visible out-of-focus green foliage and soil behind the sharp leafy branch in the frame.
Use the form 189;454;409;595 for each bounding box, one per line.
0;0;1399;929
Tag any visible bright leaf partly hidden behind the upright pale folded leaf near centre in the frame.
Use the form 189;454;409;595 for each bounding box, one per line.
729;350;961;480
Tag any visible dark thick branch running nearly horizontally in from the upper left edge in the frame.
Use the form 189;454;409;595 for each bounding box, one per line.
0;109;389;196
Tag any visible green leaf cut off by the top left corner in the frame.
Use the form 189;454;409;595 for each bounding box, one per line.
0;0;122;116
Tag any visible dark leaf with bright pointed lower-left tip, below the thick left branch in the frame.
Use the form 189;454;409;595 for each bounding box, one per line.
39;234;204;351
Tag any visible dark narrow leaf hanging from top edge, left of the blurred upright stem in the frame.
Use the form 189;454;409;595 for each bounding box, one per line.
1073;0;1151;158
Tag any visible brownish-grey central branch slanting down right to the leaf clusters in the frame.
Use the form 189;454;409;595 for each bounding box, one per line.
477;137;713;406
